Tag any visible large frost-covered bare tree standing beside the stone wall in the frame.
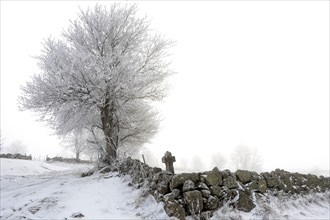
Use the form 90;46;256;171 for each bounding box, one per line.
19;4;172;162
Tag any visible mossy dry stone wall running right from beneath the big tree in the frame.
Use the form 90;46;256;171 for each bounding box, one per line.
101;158;330;219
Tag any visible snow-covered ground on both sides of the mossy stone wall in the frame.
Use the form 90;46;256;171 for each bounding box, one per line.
0;158;330;220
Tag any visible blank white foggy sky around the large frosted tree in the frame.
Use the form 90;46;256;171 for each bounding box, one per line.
1;1;329;174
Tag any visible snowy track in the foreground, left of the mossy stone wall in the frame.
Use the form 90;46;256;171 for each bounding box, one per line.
0;160;168;219
